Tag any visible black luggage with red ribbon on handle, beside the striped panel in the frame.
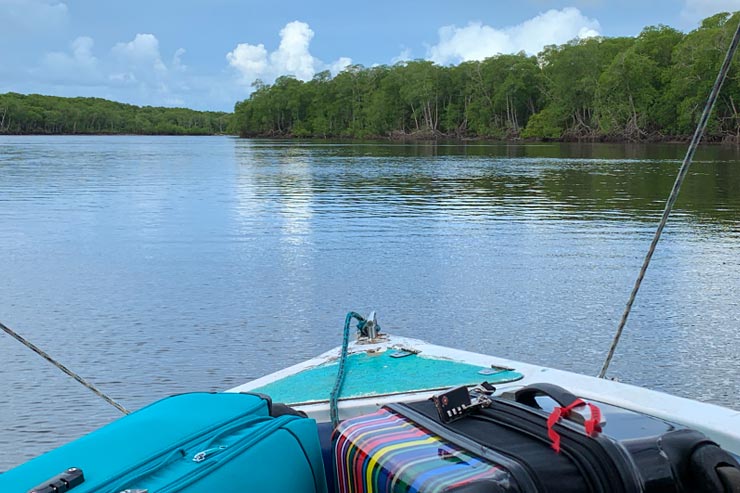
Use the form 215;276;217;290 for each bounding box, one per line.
387;384;740;493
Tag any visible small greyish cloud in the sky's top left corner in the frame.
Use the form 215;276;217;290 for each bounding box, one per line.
0;0;68;34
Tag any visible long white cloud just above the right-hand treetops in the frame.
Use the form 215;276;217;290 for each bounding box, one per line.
427;7;601;64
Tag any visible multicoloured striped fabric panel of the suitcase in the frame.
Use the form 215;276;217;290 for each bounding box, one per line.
334;408;514;493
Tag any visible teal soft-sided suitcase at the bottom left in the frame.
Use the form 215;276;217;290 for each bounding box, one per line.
0;393;326;493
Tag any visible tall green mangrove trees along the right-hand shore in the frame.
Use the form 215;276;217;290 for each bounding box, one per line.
233;13;740;142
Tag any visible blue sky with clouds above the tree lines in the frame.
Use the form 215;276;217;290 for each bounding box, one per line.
0;0;740;111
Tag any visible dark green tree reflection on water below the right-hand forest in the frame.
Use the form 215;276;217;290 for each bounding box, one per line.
237;141;740;222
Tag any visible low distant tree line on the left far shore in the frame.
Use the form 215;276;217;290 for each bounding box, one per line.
0;93;231;135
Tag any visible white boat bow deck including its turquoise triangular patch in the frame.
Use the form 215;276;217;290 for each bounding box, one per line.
230;336;740;454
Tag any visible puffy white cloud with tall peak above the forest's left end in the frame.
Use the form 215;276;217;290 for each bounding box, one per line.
226;21;352;86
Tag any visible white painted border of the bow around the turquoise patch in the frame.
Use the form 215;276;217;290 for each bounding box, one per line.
229;337;740;455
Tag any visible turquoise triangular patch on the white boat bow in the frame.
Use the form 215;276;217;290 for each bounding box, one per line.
253;351;522;404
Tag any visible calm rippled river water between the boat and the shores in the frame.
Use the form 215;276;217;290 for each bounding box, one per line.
0;137;740;470
